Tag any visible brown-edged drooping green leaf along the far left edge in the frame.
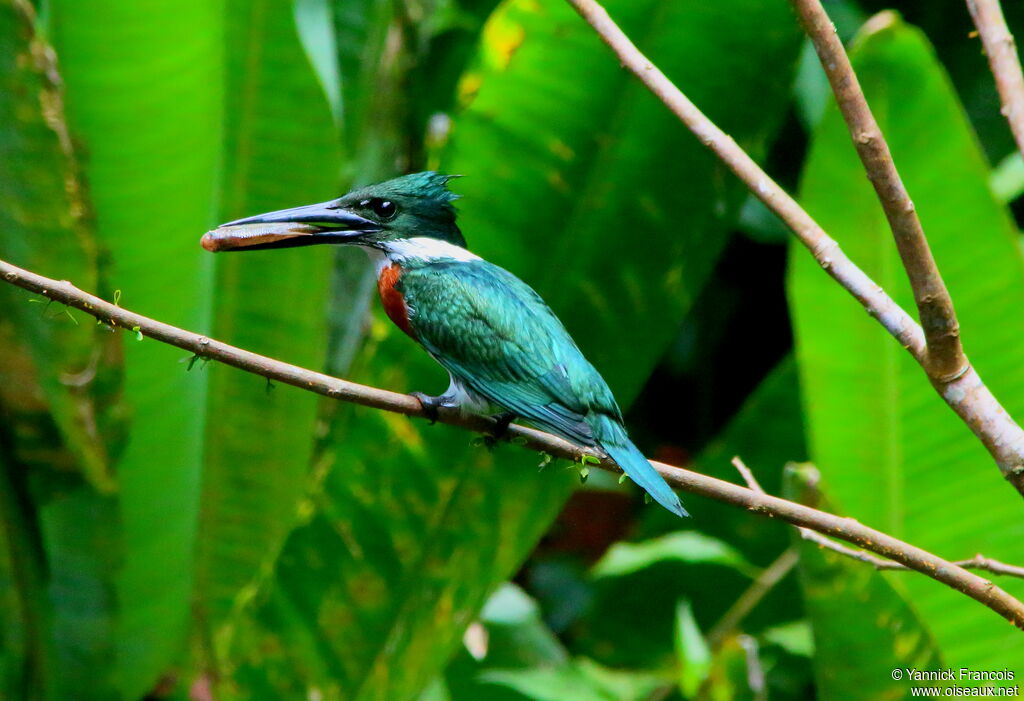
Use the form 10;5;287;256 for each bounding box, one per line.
0;0;114;492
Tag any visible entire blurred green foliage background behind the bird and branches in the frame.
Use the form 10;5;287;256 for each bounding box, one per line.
0;0;1024;701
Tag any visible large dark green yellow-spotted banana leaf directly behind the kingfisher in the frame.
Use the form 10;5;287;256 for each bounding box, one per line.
228;0;798;699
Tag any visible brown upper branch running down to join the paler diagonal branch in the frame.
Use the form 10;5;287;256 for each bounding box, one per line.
792;0;968;384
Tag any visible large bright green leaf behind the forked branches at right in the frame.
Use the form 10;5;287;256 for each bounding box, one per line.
790;14;1024;666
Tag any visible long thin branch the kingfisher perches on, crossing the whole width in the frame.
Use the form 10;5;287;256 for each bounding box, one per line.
0;255;1024;629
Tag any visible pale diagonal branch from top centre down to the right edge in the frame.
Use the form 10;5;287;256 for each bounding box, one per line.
566;0;1024;495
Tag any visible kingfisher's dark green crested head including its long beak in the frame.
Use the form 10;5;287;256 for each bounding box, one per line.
201;171;466;252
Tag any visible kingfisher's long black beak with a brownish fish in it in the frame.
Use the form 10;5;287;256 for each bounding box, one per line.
200;202;381;253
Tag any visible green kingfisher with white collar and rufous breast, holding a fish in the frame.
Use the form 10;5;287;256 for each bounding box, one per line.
201;172;688;516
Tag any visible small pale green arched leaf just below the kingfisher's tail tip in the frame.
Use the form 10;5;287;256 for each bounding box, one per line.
593;531;757;577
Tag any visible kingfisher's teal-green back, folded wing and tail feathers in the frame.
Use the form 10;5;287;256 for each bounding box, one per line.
396;260;686;516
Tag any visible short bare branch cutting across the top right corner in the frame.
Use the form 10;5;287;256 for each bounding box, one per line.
967;0;1024;155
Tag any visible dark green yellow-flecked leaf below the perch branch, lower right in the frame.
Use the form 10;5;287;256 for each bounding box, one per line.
786;466;944;700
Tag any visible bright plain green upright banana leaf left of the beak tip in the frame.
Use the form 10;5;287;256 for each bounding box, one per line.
49;0;223;698
